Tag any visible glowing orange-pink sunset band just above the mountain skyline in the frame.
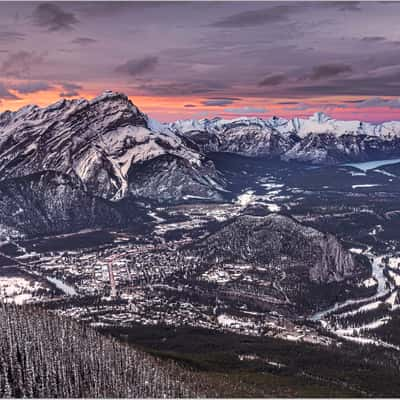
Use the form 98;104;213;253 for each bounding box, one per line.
0;88;400;122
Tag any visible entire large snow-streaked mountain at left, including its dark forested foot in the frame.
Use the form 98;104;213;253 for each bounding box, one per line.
0;92;223;236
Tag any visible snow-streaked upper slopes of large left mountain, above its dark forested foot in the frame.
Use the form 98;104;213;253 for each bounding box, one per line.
0;91;219;201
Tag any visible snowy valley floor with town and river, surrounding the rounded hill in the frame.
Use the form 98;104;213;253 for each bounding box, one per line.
0;155;400;350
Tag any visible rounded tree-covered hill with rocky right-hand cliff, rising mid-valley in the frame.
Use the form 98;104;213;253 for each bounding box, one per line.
200;214;359;283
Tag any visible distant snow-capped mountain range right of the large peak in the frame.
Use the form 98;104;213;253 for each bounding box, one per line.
164;112;400;164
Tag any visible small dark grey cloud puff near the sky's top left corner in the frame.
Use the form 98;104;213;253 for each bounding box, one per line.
32;3;79;32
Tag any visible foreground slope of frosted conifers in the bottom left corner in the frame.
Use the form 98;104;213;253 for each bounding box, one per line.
0;305;201;398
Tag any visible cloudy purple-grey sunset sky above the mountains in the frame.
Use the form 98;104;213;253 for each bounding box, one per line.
0;1;400;122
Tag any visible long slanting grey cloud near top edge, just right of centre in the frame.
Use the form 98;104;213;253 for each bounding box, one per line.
211;5;292;28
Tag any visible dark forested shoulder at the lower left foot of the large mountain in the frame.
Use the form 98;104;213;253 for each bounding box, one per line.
0;171;137;236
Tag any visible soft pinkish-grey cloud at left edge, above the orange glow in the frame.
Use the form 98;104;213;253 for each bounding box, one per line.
0;50;44;78
